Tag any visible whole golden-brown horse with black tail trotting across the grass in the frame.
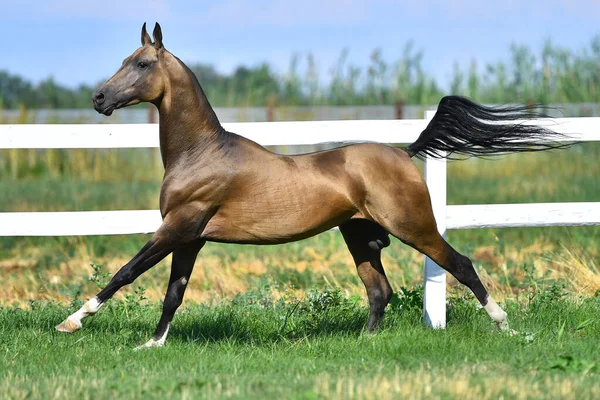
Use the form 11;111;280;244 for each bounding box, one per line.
56;23;562;347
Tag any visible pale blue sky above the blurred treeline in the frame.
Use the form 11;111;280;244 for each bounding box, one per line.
0;0;600;90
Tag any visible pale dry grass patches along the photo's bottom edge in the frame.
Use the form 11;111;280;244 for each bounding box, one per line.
1;366;600;400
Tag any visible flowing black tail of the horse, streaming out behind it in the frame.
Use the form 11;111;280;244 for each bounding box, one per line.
406;96;571;159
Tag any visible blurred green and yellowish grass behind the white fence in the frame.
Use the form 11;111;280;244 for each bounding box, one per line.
0;143;600;303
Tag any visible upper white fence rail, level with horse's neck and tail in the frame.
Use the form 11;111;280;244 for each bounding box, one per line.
0;117;600;149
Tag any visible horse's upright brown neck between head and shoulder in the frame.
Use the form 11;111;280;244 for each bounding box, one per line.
157;54;225;168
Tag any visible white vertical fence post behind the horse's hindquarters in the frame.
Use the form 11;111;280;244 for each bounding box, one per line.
423;111;446;329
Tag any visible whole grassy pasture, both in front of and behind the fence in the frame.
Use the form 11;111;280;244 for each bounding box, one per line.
0;143;600;398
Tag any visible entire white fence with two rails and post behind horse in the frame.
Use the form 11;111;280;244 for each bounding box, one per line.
0;112;600;328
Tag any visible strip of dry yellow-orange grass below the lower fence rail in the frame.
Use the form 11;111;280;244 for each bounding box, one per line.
0;233;600;304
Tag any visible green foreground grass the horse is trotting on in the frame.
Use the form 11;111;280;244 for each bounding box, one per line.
0;286;600;399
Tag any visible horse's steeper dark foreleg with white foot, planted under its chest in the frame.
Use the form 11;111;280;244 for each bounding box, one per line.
137;240;206;349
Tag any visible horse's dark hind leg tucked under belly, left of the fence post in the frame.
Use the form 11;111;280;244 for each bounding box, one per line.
340;220;393;332
